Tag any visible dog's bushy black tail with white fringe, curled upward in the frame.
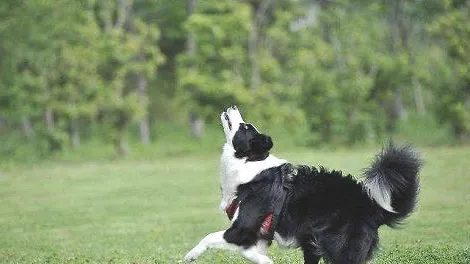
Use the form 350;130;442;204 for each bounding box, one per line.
364;142;422;226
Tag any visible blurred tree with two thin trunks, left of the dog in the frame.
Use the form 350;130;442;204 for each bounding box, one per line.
90;0;164;155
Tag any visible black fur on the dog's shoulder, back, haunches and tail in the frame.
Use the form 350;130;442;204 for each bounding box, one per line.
224;142;421;264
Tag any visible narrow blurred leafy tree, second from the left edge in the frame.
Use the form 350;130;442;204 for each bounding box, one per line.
50;13;103;147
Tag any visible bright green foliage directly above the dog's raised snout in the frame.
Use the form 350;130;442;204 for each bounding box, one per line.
179;1;251;118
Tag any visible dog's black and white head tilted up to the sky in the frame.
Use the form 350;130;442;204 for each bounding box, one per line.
220;106;273;161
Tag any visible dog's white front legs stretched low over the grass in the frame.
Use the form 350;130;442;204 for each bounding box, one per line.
184;231;273;264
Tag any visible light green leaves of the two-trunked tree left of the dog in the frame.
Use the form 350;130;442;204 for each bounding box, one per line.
94;17;163;125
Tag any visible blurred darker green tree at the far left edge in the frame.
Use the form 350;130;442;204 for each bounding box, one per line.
0;0;81;150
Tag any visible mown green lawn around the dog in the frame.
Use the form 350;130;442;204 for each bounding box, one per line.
0;145;470;264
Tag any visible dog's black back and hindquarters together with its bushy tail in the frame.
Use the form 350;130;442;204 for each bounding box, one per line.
276;144;421;264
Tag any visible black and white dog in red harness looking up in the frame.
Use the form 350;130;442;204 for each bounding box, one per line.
185;107;421;264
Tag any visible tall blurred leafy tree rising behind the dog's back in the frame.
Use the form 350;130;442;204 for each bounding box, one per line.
290;1;384;143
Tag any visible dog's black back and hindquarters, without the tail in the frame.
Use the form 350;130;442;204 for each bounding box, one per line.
276;166;379;263
